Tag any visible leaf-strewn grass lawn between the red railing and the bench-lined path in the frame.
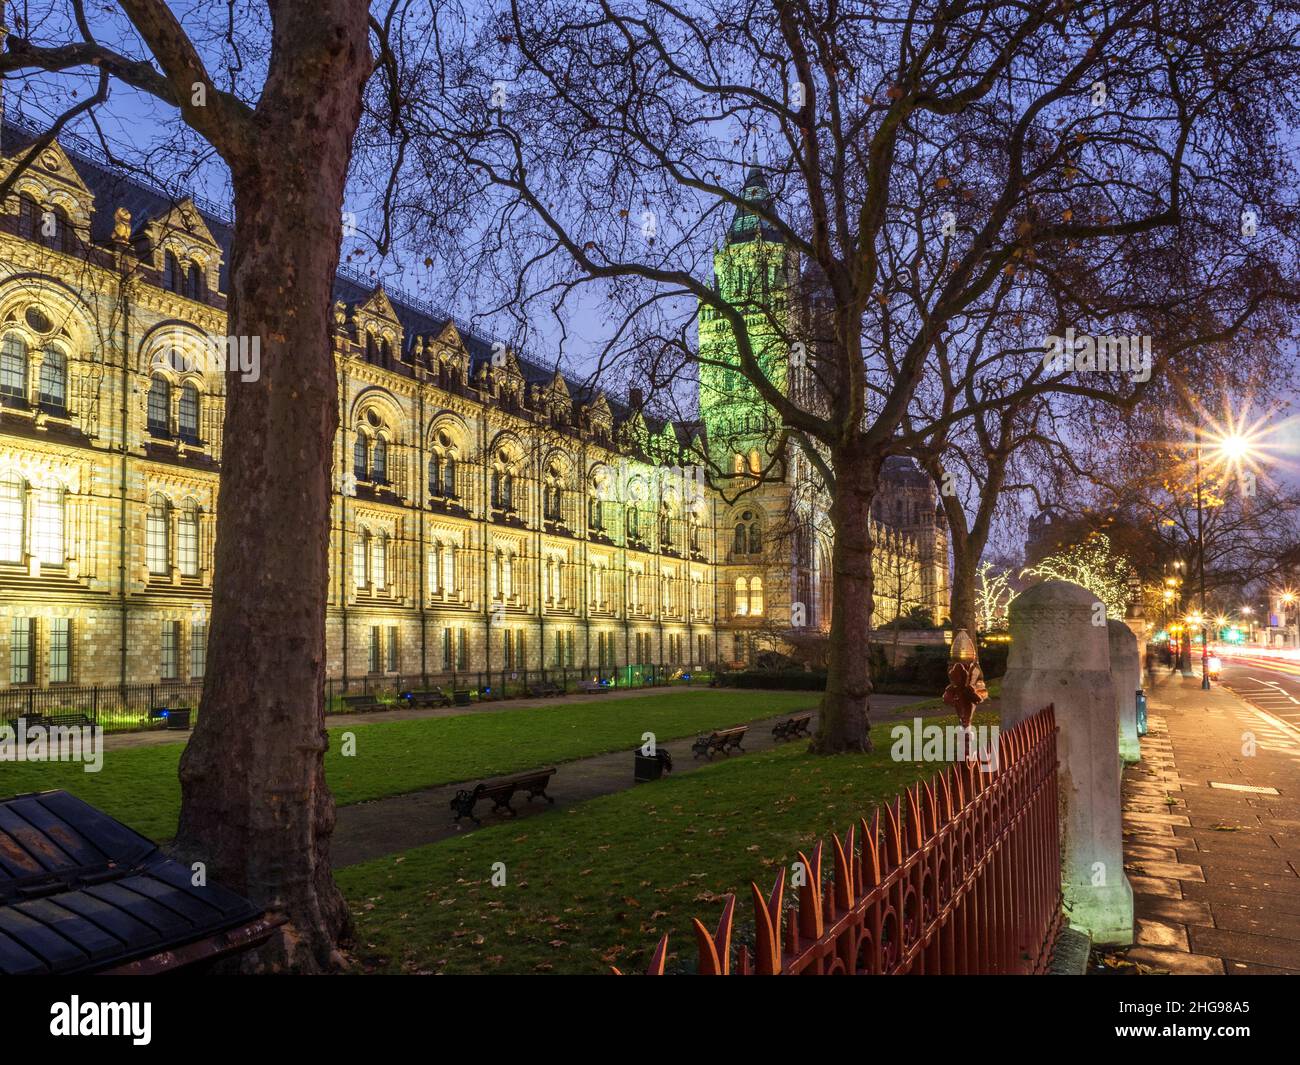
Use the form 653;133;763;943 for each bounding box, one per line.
335;718;957;974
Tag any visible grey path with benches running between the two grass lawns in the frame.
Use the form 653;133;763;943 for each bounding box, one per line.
330;690;935;869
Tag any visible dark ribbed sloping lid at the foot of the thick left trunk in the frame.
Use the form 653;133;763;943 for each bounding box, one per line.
0;791;283;975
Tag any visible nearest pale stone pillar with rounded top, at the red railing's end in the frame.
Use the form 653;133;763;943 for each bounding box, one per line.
1001;580;1134;945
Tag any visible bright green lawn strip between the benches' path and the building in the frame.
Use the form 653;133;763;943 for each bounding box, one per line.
0;689;820;840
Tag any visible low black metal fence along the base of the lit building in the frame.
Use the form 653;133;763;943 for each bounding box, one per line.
0;663;715;732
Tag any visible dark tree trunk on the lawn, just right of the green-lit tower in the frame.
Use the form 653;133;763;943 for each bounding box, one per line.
811;449;880;754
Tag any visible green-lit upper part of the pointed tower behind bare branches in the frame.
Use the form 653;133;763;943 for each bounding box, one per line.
699;166;798;473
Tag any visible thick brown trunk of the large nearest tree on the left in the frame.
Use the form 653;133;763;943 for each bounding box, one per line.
177;0;371;971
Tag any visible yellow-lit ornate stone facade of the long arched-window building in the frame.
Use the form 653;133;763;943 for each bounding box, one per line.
0;124;946;689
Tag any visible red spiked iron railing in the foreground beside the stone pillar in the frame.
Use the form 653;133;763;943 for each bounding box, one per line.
614;706;1061;975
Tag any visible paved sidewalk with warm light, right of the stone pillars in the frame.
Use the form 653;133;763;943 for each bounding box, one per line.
1123;670;1300;975
